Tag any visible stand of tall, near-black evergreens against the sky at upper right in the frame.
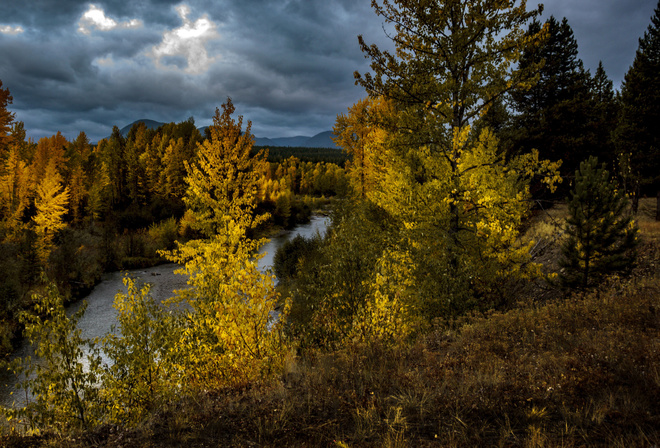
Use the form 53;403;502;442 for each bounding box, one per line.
492;15;660;206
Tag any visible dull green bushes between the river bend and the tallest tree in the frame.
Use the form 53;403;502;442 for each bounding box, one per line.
286;203;390;349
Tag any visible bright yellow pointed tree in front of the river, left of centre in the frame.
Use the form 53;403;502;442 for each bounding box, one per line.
166;99;285;388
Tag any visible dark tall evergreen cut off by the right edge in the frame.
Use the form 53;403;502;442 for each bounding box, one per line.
617;2;660;206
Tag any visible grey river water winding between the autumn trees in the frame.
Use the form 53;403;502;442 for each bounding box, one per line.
0;216;330;407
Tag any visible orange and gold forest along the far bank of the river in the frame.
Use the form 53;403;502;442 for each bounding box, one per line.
0;89;346;356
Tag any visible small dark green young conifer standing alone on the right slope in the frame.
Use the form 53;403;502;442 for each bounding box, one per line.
561;157;638;288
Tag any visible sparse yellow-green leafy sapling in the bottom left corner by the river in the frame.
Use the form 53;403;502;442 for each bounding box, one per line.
4;285;102;432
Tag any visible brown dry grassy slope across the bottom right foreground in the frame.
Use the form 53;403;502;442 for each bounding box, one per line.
7;201;660;447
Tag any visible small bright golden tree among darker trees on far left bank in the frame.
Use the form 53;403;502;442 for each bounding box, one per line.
32;160;69;264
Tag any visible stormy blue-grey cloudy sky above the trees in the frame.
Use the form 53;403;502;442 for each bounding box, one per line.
0;0;658;142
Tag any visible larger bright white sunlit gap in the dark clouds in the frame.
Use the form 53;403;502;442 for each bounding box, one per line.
151;4;220;75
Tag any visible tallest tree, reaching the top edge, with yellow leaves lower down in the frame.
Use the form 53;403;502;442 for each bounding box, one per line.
355;0;555;315
